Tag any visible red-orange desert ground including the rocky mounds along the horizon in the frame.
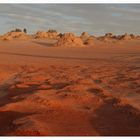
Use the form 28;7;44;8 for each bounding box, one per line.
0;31;140;136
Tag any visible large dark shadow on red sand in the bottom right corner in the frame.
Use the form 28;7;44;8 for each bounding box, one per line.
91;99;140;136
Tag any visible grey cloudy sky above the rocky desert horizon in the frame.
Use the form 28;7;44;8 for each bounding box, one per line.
0;4;140;35
